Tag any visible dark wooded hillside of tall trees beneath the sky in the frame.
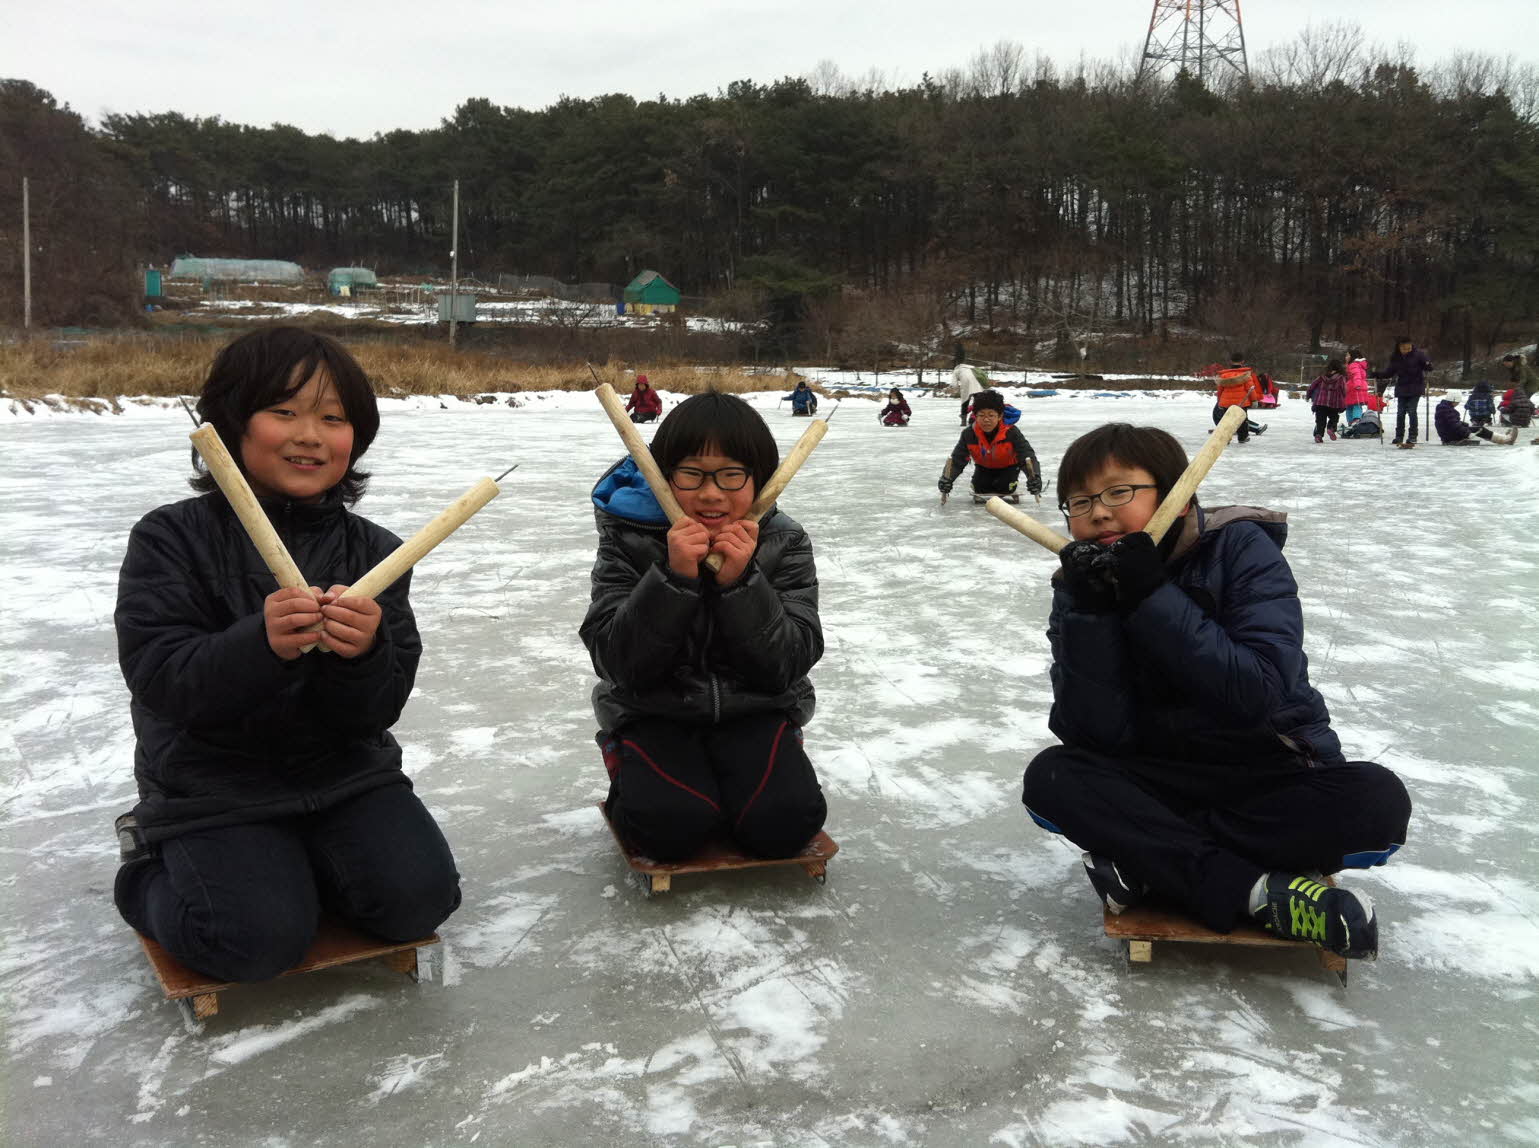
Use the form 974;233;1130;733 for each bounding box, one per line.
0;38;1539;359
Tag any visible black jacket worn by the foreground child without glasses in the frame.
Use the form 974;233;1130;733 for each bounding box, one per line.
114;491;422;840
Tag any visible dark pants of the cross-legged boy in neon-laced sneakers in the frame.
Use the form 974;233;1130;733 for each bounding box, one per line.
1022;745;1411;933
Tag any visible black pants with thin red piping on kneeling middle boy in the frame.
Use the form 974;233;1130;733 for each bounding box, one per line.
605;714;828;862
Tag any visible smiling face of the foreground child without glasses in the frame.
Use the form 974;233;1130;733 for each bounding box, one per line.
240;361;352;502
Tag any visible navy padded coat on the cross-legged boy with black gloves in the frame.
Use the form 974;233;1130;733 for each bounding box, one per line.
1048;506;1344;793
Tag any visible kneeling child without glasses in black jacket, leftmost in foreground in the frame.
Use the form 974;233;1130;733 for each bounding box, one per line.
114;328;460;980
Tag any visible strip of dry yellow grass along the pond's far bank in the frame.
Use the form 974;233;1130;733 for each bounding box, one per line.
0;335;793;399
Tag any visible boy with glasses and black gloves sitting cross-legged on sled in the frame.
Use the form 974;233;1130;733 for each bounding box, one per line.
1022;423;1411;957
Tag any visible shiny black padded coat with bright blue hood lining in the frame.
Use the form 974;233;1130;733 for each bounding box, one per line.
579;459;823;733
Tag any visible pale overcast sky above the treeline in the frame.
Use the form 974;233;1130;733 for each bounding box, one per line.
12;0;1539;137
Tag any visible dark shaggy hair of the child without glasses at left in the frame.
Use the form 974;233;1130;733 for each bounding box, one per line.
188;326;380;506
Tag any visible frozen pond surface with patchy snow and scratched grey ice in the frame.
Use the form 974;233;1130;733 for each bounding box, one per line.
0;386;1539;1146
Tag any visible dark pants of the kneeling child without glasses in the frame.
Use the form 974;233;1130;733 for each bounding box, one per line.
114;785;460;980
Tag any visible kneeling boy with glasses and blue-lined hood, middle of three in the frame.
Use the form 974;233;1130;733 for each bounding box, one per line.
580;391;826;862
